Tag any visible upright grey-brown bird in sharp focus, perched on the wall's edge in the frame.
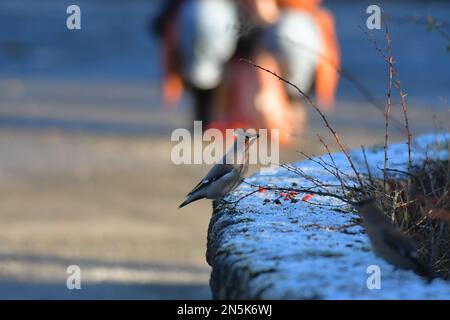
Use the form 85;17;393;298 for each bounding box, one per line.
178;129;259;208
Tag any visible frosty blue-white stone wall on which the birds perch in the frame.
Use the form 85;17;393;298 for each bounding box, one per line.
206;134;450;299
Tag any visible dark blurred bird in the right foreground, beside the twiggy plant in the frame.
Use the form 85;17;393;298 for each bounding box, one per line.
355;198;434;281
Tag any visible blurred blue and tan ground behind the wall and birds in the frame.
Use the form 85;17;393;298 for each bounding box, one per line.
0;0;450;299
